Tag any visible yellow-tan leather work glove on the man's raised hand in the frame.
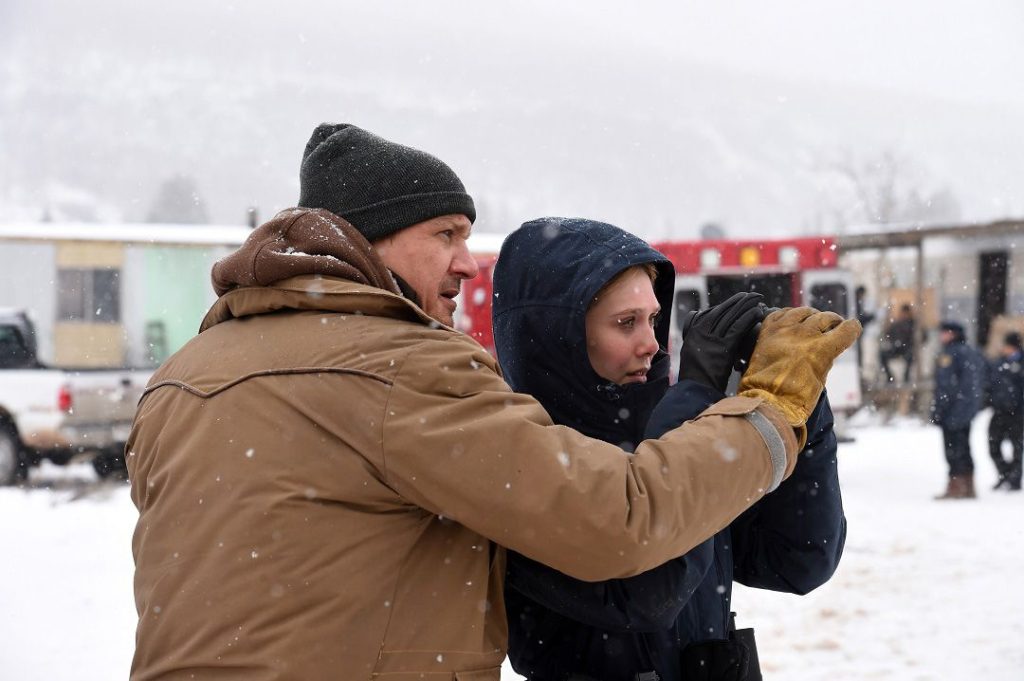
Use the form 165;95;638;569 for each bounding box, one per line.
737;307;861;450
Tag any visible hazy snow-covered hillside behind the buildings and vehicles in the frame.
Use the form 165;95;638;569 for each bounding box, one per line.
0;0;1024;239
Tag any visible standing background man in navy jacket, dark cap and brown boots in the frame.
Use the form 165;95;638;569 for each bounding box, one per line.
932;322;985;499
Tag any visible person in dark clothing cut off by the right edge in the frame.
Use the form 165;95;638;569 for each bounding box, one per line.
988;332;1024;492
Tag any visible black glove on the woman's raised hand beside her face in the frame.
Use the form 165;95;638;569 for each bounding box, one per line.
679;293;766;392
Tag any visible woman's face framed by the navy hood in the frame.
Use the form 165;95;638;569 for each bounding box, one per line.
587;267;662;385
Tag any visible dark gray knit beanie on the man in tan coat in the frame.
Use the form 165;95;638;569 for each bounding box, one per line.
299;123;476;242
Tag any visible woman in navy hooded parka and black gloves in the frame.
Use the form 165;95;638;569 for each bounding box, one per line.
494;218;845;681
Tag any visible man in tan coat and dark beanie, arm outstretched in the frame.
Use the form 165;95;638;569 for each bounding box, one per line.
128;124;859;681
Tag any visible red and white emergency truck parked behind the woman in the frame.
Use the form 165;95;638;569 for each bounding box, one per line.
456;235;861;414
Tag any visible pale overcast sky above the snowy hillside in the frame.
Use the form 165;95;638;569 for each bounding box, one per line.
9;0;1024;102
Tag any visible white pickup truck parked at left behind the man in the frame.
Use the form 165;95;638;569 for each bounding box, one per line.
0;309;152;484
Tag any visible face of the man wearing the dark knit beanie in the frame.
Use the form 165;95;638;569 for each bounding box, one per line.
374;215;480;327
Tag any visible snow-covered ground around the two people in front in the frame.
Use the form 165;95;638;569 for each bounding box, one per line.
0;414;1024;681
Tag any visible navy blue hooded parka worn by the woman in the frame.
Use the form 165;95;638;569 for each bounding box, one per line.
493;218;846;681
